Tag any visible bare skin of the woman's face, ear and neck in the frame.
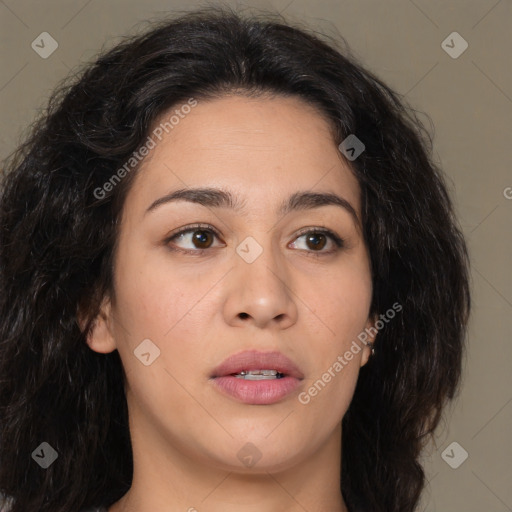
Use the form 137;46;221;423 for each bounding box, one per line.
88;96;375;512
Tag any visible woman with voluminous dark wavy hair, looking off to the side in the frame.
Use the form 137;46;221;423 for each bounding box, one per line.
0;8;470;512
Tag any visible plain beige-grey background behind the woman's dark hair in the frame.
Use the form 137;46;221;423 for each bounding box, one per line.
0;0;512;512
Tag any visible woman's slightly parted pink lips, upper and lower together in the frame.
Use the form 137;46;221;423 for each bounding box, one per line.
210;350;304;405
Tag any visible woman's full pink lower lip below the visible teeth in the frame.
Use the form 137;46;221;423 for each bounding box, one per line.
213;375;300;405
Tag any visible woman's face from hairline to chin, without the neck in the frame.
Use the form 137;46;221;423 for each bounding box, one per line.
89;96;372;472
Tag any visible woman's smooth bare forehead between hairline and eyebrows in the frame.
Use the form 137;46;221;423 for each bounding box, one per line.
127;96;360;216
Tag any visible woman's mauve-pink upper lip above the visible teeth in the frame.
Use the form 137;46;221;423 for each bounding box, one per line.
211;350;304;379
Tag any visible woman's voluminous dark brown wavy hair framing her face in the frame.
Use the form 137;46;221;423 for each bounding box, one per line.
0;6;470;512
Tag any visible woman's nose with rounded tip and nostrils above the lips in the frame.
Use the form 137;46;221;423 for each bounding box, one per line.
224;241;298;329
